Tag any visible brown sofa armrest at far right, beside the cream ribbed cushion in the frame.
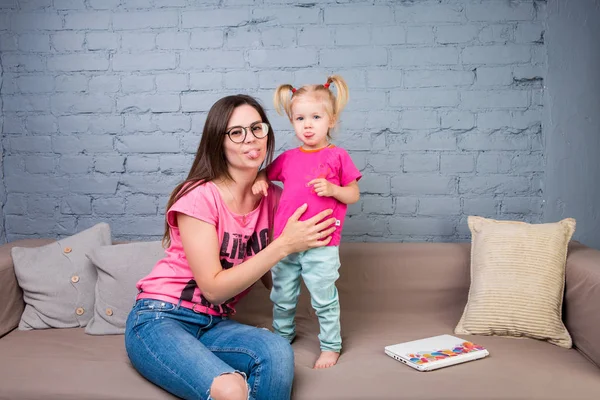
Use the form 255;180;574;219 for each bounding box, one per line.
564;242;600;367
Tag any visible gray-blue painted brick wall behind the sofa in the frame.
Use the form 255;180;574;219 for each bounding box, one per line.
0;0;546;241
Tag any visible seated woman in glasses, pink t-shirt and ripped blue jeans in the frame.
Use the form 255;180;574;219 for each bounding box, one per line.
125;95;335;400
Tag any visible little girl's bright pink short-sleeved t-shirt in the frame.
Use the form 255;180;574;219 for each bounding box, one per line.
267;145;362;246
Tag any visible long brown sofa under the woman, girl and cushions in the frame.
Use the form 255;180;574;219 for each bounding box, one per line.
0;239;600;400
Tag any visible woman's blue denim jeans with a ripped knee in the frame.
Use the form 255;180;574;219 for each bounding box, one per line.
125;299;294;400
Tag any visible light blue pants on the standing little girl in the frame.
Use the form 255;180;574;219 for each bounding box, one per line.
271;246;342;352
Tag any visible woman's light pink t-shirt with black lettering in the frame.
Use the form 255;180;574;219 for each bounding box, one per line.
137;182;281;315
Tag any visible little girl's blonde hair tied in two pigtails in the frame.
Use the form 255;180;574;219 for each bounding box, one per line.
273;75;348;135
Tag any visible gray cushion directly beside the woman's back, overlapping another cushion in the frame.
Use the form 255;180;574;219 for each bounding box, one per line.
85;241;165;335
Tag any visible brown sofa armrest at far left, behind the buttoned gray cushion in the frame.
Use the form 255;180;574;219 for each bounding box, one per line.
0;239;54;337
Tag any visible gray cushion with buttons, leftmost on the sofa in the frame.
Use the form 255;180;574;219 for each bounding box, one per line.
11;223;111;330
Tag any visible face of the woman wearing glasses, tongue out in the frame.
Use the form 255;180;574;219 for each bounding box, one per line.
223;104;268;171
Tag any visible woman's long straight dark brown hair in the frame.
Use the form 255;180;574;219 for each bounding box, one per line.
162;94;275;248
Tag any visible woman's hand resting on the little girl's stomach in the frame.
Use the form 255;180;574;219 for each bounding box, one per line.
279;204;335;254
